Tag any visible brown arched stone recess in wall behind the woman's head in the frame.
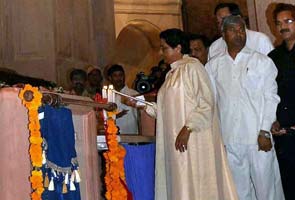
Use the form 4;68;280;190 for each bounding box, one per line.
112;19;161;87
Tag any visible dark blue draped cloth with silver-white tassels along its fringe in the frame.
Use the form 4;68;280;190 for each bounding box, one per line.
39;105;81;200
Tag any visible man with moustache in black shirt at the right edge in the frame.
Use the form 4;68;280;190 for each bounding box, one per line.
269;3;295;200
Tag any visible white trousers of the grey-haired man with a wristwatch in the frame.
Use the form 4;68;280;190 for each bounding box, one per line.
226;144;285;200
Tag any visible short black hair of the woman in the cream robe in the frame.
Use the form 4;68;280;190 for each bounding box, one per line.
160;28;189;54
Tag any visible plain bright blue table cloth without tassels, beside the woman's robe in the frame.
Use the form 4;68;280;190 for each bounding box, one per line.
123;144;155;200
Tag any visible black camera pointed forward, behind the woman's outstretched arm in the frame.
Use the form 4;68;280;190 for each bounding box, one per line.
134;72;156;94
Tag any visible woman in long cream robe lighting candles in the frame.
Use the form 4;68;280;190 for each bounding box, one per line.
146;29;238;200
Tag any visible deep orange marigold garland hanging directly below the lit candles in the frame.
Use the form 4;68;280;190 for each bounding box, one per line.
103;112;127;200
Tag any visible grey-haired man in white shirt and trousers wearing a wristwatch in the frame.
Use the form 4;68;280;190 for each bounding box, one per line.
206;15;284;200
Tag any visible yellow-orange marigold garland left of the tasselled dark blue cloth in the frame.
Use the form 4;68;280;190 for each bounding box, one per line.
19;84;44;200
